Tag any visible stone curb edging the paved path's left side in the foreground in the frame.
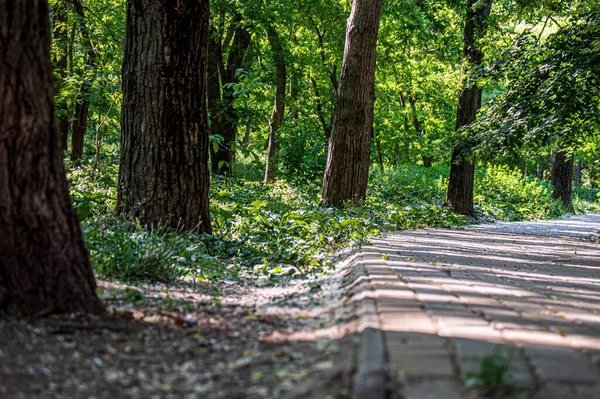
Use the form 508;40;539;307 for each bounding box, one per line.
352;255;387;399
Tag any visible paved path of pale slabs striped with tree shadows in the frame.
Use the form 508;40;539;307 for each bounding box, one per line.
355;215;600;399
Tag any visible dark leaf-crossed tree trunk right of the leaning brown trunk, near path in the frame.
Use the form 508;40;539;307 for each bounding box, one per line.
446;0;493;216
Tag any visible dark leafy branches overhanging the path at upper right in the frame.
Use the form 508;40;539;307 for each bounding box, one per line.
475;3;600;152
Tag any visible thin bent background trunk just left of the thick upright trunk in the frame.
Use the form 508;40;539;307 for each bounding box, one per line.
71;0;98;161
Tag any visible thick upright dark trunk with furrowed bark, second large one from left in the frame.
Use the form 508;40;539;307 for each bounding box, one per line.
117;0;211;233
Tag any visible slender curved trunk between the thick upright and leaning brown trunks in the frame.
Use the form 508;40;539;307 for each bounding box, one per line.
265;26;287;183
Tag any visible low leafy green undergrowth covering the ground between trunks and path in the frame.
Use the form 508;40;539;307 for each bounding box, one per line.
69;160;600;286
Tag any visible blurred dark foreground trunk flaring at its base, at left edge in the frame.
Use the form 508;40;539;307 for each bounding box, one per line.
0;0;104;315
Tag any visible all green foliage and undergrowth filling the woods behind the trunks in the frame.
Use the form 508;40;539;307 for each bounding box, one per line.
51;0;600;283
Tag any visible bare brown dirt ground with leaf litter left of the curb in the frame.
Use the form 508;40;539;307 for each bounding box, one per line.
0;262;356;399
